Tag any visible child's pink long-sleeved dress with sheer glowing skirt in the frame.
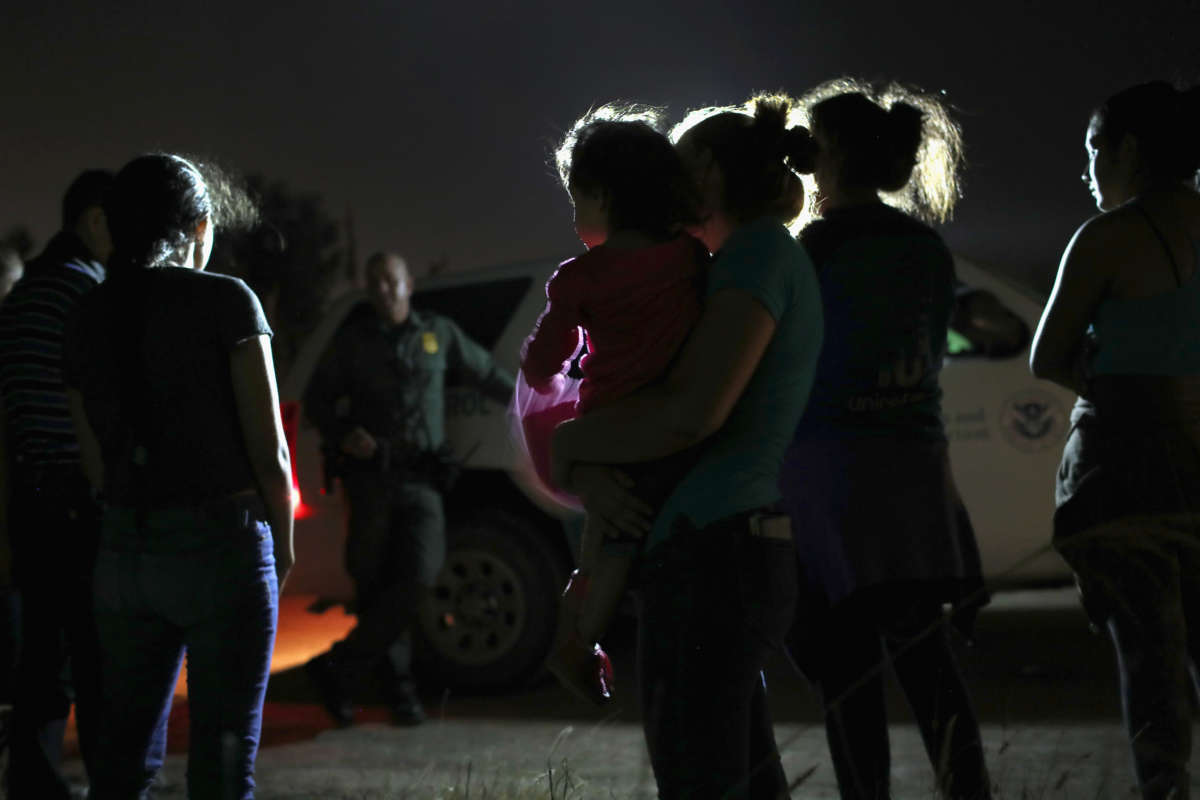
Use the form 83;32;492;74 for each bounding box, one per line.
512;235;708;507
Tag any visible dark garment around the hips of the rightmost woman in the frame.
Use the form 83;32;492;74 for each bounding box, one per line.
1054;375;1200;628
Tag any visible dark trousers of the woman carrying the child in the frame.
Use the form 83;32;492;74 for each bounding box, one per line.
637;516;797;800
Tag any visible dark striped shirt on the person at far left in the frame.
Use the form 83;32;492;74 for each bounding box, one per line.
0;233;104;468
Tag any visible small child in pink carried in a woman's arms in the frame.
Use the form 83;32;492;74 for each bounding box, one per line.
516;107;708;703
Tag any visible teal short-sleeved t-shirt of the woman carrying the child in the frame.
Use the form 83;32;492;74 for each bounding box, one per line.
647;218;824;547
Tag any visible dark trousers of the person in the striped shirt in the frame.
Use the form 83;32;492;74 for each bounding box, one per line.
7;470;100;800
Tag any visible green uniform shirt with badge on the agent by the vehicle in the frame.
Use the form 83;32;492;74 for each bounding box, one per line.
305;306;514;455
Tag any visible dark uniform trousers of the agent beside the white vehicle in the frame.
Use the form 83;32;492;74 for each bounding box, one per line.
334;471;446;682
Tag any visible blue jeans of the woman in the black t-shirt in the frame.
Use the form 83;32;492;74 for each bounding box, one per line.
91;498;278;800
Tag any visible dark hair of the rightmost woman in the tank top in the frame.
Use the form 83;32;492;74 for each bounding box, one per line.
1092;80;1200;184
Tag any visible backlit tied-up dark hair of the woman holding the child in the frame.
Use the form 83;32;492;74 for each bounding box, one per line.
672;95;816;224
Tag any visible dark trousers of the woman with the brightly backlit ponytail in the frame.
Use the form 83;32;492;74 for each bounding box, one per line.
791;594;991;800
